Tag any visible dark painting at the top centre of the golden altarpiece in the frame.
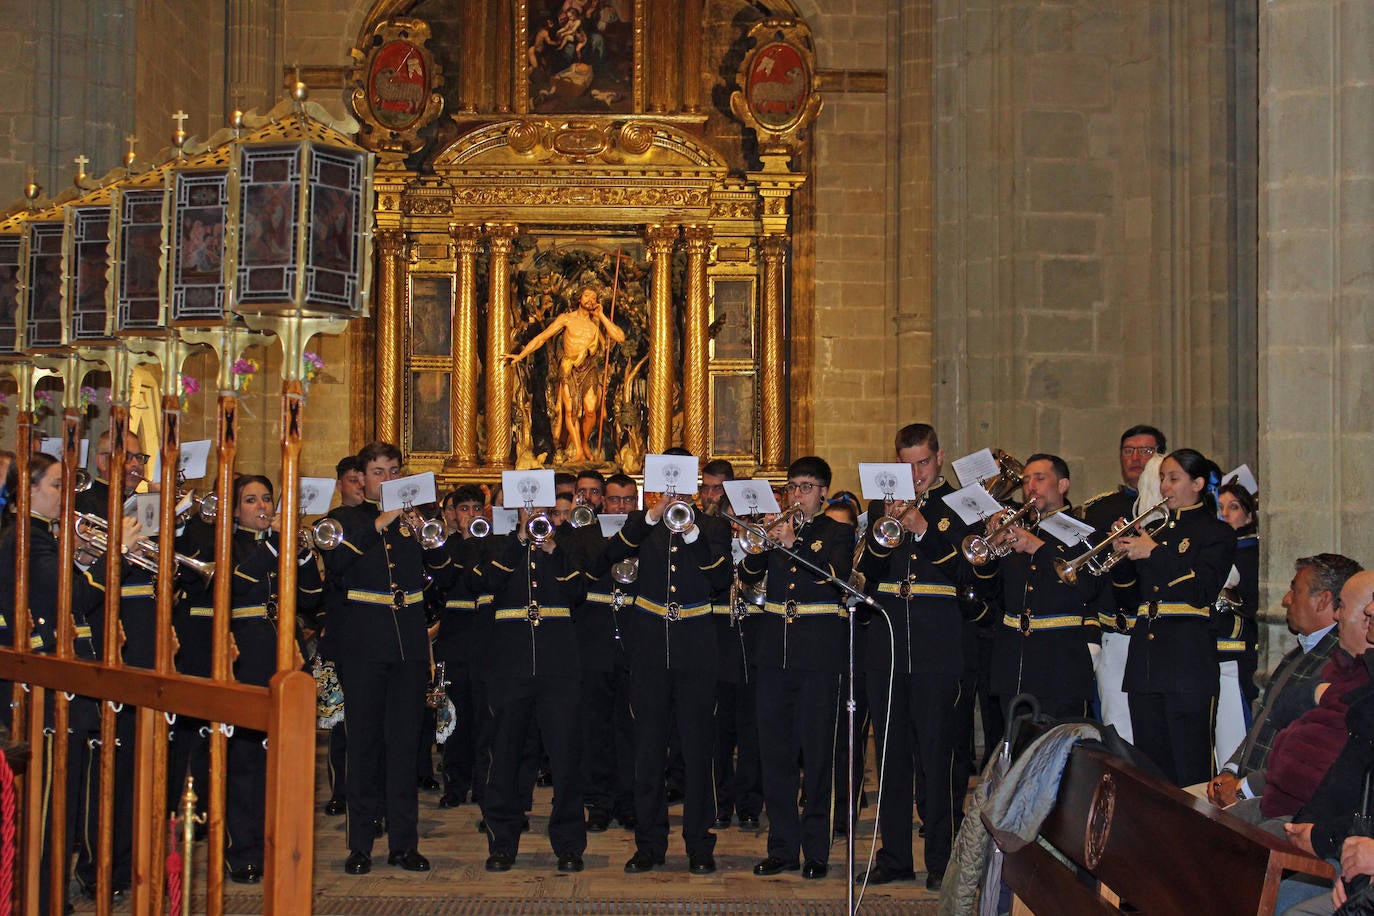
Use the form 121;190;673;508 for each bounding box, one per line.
518;0;635;114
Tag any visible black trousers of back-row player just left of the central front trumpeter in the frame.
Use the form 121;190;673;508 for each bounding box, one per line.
581;665;635;817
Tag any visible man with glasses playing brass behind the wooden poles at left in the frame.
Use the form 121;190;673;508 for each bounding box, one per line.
67;430;158;900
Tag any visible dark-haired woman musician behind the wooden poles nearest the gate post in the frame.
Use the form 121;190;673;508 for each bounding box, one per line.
225;474;322;884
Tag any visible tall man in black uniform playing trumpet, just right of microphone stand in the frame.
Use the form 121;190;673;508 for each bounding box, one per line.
859;423;973;890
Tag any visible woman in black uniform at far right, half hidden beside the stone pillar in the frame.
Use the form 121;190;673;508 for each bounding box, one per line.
1215;479;1260;770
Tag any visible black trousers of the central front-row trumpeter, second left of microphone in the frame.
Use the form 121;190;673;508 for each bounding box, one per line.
629;666;716;858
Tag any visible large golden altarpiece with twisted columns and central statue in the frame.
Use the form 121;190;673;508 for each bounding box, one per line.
346;0;820;479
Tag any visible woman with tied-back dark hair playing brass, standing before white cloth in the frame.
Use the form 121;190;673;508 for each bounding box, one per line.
1114;449;1235;786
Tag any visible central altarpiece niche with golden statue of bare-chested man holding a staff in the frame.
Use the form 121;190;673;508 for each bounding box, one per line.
510;239;650;472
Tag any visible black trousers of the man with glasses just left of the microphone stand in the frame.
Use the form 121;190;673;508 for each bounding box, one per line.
757;667;840;864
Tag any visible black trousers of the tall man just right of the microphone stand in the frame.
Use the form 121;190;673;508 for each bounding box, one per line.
868;670;967;872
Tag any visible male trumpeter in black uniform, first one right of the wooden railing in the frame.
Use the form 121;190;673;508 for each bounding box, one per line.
324;442;449;875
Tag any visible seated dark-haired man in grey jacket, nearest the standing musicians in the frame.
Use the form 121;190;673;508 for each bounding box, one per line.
1206;553;1362;808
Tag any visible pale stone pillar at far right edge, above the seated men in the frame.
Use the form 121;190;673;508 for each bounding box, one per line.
1259;0;1374;669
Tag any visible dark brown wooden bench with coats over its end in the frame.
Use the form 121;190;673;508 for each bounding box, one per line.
982;746;1334;916
